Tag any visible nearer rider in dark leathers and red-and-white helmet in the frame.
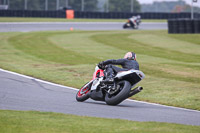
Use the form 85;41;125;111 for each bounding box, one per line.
98;52;139;83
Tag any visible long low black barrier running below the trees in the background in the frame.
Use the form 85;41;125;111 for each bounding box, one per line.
0;10;200;19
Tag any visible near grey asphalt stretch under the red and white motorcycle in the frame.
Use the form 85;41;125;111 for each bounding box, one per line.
0;69;200;126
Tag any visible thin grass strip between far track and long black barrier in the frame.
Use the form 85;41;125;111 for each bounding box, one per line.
0;17;167;22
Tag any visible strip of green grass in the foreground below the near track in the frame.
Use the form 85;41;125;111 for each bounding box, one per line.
0;110;200;133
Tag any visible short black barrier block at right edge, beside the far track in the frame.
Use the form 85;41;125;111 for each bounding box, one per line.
168;19;200;34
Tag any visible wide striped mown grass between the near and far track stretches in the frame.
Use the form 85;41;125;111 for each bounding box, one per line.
0;31;200;110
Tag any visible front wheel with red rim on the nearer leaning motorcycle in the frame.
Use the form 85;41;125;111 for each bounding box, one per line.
76;82;93;102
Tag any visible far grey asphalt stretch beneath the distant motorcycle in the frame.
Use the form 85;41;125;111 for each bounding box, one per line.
0;22;167;32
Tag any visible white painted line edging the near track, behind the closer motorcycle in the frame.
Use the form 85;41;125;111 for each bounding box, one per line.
0;68;200;113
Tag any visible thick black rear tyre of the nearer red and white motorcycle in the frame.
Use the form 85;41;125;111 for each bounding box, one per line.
105;80;131;105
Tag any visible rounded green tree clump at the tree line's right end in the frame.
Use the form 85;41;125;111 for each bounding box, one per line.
109;0;141;12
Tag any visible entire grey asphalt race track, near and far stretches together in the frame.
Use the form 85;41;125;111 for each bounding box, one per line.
0;22;200;125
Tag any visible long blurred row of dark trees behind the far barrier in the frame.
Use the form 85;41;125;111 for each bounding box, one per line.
4;0;141;12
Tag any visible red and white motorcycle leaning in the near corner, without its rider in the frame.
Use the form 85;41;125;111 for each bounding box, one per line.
76;65;145;105
